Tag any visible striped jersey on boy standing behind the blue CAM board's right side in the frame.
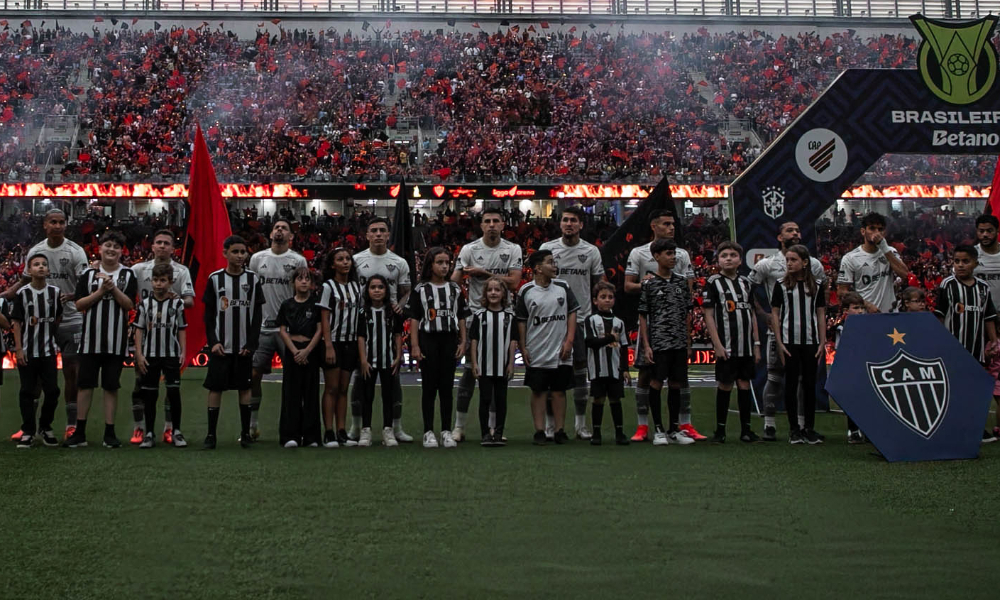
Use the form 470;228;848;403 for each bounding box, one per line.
934;275;997;362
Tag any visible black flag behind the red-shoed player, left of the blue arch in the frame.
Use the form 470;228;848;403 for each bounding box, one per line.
601;177;684;329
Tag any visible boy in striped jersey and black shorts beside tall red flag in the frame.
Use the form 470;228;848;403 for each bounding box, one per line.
202;235;264;450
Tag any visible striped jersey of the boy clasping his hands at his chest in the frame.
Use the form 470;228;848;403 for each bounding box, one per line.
76;266;139;356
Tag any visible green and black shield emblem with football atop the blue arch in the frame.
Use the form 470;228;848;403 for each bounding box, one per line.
910;14;997;105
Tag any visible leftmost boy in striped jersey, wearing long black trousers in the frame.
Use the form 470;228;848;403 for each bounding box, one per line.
10;254;55;448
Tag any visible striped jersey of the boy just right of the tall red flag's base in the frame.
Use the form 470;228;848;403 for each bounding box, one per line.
202;269;264;354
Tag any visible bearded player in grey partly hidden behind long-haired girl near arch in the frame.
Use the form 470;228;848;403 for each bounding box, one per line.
748;221;826;442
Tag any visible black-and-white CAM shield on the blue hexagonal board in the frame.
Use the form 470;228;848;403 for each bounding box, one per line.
867;350;949;439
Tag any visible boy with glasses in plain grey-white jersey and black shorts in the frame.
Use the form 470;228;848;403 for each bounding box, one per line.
514;250;580;446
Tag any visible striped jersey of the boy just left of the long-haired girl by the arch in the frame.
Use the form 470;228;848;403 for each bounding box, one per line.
703;273;754;357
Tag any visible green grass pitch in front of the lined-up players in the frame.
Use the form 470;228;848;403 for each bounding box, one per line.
0;369;1000;599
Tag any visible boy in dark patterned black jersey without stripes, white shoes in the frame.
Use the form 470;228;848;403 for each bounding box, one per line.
639;239;694;446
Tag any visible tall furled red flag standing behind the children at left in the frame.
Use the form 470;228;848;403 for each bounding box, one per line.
184;125;233;365
